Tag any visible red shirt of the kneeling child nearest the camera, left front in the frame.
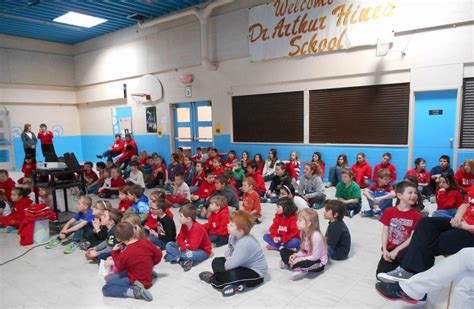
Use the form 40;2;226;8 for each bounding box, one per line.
112;238;163;289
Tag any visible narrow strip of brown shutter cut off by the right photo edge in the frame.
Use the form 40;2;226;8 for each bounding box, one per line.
460;78;474;148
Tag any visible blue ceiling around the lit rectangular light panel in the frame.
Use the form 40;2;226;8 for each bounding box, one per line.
0;0;208;45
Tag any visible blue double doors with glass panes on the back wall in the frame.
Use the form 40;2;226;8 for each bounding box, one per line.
173;101;213;154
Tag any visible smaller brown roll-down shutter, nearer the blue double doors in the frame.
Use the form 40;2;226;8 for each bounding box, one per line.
232;91;304;143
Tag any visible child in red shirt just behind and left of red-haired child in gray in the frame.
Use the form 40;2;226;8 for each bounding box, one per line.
204;195;229;247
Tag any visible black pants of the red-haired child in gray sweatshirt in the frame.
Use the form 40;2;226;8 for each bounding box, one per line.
211;257;263;290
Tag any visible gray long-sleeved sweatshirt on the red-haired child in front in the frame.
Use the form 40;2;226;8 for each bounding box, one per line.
225;234;268;278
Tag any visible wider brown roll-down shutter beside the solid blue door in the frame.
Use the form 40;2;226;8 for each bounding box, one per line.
309;83;410;145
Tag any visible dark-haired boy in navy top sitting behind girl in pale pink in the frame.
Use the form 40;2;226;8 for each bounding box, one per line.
324;200;351;261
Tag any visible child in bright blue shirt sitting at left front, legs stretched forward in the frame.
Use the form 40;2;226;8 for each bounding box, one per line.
46;196;94;254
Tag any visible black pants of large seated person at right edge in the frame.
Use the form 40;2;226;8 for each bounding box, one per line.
401;217;474;273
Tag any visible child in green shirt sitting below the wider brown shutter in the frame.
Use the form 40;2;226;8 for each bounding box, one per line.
336;169;362;218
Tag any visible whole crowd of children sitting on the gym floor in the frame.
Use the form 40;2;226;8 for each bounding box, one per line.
0;148;474;301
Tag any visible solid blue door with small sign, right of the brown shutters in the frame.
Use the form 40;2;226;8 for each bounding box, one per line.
413;90;457;169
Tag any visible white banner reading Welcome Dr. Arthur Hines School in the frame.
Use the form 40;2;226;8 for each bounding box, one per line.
248;0;395;61
